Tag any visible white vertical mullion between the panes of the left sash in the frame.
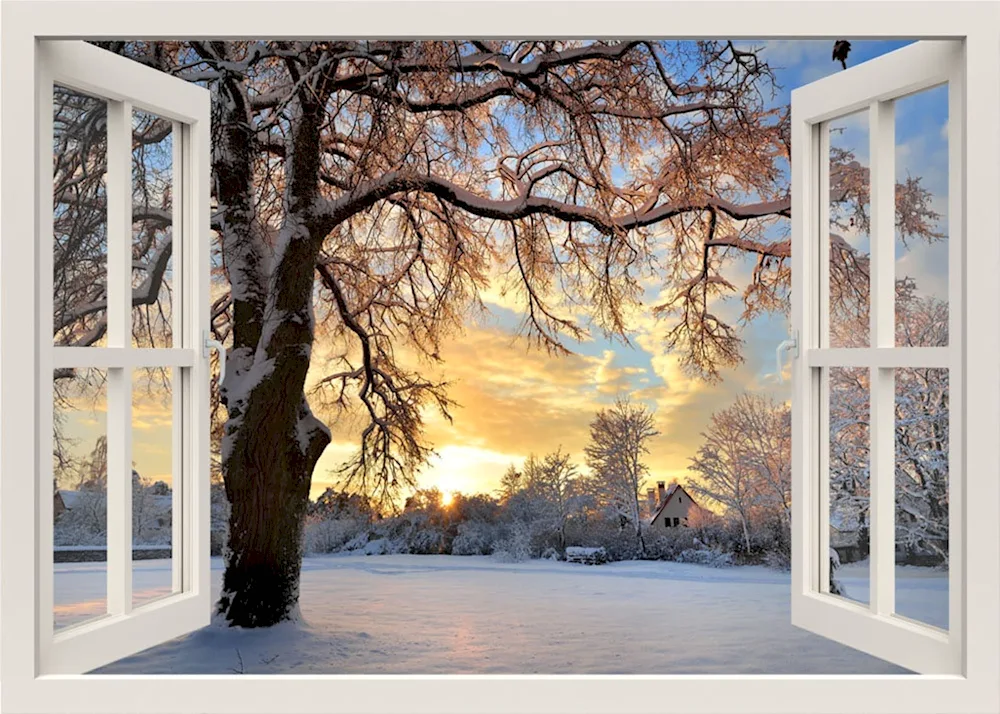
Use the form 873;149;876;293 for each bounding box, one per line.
106;101;132;615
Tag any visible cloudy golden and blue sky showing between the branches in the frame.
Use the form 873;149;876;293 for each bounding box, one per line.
58;40;948;504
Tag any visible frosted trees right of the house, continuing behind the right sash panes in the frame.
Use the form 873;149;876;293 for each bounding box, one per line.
688;281;949;564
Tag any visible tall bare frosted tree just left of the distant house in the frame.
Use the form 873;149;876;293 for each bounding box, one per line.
585;397;660;556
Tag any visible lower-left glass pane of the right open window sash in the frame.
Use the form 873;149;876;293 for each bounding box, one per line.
829;367;871;603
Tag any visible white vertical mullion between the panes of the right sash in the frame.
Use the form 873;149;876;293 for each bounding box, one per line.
869;101;896;615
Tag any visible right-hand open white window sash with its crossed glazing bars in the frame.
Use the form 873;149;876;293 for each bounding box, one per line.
791;41;965;675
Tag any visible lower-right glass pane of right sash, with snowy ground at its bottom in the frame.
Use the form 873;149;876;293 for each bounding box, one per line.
896;369;948;629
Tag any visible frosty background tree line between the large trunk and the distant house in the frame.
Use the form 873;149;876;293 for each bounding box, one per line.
296;398;688;560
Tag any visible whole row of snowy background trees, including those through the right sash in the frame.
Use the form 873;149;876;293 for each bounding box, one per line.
305;326;949;567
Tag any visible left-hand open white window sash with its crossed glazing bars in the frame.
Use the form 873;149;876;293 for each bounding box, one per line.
35;41;211;675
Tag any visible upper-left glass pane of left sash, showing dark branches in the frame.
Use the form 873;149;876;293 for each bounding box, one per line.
52;86;108;347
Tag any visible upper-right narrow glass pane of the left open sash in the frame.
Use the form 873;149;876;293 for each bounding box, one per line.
132;110;174;347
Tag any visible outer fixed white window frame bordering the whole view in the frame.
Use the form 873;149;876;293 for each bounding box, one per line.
0;0;1000;714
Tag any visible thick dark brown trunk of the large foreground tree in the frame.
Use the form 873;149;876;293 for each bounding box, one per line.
218;228;330;627
